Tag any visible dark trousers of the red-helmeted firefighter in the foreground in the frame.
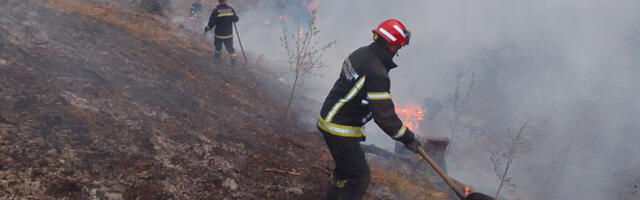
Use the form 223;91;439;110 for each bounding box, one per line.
319;129;371;200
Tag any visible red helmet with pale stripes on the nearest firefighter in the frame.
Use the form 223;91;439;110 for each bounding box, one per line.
373;19;411;46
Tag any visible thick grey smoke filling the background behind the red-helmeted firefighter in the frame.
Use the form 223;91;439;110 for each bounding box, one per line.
179;0;640;199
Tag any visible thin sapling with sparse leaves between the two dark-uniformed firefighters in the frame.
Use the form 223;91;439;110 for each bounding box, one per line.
281;11;336;116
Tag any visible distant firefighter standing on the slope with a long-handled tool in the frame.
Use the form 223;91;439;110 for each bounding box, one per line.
204;0;239;66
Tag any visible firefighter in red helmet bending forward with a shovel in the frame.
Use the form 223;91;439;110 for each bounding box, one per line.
317;19;420;200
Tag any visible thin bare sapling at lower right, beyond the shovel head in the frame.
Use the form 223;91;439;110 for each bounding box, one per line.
490;122;529;199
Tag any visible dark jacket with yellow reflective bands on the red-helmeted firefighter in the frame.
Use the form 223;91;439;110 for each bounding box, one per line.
318;42;414;144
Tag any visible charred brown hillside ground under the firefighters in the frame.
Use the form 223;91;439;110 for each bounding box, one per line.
0;0;447;199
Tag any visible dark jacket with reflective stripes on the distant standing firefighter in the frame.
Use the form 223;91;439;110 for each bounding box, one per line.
207;4;240;39
